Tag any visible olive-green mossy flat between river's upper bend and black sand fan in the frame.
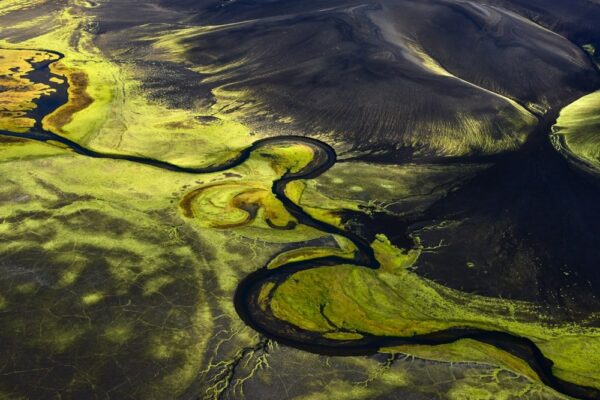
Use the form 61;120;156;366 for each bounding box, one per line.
296;161;487;219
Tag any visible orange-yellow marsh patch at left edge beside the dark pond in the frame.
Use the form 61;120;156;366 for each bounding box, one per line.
0;48;58;132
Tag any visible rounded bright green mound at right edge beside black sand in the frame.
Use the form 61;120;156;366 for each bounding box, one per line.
552;91;600;173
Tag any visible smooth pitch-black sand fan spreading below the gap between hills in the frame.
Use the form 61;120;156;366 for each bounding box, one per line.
346;109;600;322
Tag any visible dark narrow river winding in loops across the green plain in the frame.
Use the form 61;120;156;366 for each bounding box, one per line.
0;49;600;400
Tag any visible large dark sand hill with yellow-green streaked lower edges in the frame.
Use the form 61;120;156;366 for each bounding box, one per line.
89;0;597;161
